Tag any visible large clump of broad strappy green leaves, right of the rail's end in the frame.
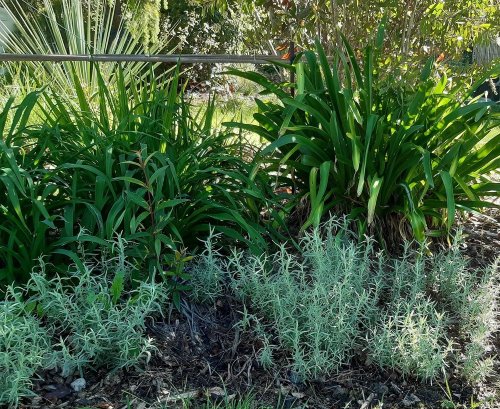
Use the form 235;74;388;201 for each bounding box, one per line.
229;34;500;242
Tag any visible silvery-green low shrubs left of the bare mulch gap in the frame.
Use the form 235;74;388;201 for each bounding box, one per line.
0;236;169;407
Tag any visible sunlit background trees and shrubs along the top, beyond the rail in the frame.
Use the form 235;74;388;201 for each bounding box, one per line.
4;0;500;74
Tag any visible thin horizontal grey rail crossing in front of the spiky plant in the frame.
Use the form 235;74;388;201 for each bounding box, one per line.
0;53;288;64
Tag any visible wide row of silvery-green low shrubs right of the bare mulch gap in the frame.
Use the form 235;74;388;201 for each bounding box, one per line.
192;221;499;383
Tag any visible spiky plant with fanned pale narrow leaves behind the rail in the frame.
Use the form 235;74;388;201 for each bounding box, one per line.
0;0;162;100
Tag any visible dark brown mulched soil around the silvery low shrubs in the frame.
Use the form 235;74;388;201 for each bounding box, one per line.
22;211;500;409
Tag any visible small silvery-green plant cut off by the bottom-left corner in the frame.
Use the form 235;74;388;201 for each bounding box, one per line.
0;289;53;407
